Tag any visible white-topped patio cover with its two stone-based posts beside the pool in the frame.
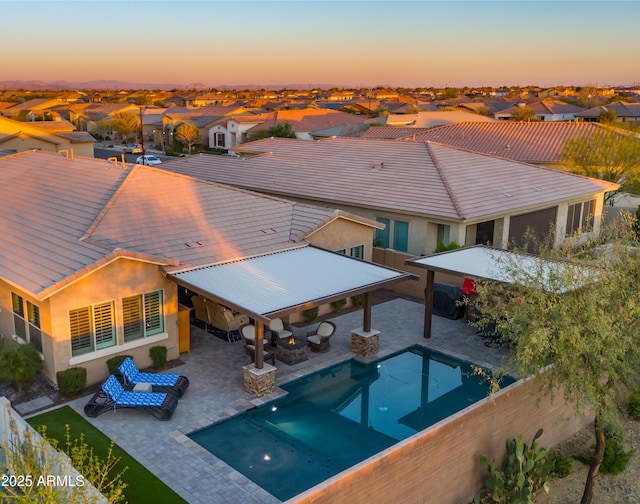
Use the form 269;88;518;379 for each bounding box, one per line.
168;246;416;397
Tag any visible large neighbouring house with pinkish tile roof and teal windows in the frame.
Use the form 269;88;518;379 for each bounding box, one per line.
162;138;618;255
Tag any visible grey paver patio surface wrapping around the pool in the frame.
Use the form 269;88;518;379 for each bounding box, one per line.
36;299;506;504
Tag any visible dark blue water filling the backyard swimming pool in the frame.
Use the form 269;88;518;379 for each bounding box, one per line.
189;347;514;501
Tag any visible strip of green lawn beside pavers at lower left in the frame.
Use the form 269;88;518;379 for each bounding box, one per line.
27;406;187;504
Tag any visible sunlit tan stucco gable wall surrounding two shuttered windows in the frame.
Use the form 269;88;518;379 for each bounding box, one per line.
41;259;178;384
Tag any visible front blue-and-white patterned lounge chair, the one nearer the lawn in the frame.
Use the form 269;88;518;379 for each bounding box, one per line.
84;375;178;420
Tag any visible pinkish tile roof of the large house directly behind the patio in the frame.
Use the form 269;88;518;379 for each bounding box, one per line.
162;138;616;224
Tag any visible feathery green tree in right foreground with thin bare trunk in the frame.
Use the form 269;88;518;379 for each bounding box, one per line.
476;222;640;504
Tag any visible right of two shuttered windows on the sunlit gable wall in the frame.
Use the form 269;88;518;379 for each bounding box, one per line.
122;291;164;342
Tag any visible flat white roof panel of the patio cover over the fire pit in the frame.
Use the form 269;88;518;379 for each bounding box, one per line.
168;246;414;324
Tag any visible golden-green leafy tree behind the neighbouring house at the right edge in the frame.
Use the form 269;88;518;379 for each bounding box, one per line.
560;128;640;193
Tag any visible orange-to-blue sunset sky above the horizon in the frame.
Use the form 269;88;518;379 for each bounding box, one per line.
5;0;640;87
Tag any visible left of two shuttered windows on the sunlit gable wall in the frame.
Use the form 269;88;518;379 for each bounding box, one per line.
69;301;116;356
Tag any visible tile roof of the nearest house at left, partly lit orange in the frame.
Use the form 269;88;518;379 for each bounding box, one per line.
0;151;360;299
